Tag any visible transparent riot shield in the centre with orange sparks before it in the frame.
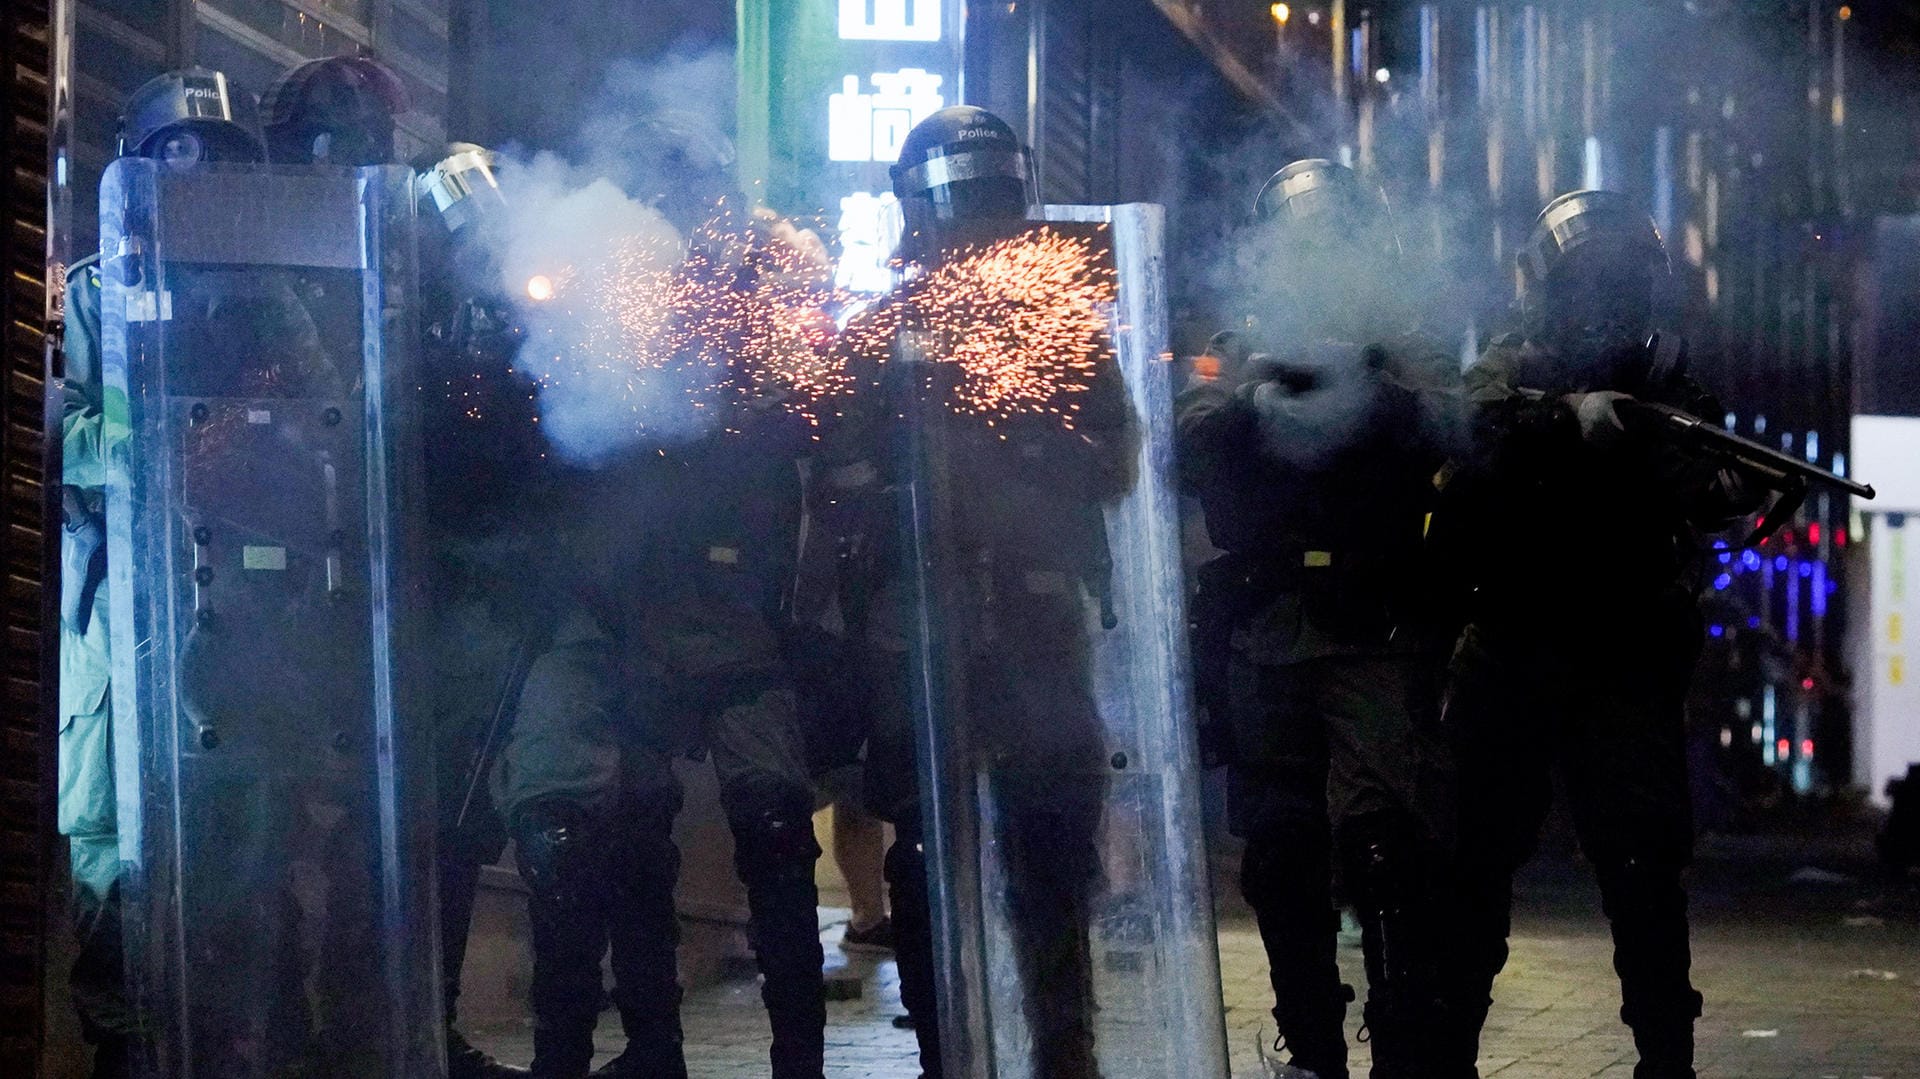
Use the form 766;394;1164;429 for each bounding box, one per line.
895;205;1227;1079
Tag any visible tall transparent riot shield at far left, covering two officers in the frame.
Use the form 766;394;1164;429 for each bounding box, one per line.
100;159;445;1079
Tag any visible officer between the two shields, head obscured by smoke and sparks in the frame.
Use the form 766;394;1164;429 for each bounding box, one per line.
501;123;826;1079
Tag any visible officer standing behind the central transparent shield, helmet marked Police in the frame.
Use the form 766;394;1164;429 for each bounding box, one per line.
818;106;1133;1079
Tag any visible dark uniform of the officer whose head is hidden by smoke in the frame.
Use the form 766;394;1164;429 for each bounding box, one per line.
497;407;826;1079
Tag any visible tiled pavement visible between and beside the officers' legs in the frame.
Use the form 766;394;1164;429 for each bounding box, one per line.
478;825;1920;1079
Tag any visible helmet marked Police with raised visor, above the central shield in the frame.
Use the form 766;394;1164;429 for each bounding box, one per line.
889;106;1037;248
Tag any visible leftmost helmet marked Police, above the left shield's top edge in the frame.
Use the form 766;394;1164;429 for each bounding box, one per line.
119;67;265;165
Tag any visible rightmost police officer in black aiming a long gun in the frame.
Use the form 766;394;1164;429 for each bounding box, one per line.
1434;190;1757;1079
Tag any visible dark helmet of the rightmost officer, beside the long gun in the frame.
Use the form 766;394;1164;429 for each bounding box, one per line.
1519;190;1672;367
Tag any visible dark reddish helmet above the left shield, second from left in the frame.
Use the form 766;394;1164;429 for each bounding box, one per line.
261;56;407;167
